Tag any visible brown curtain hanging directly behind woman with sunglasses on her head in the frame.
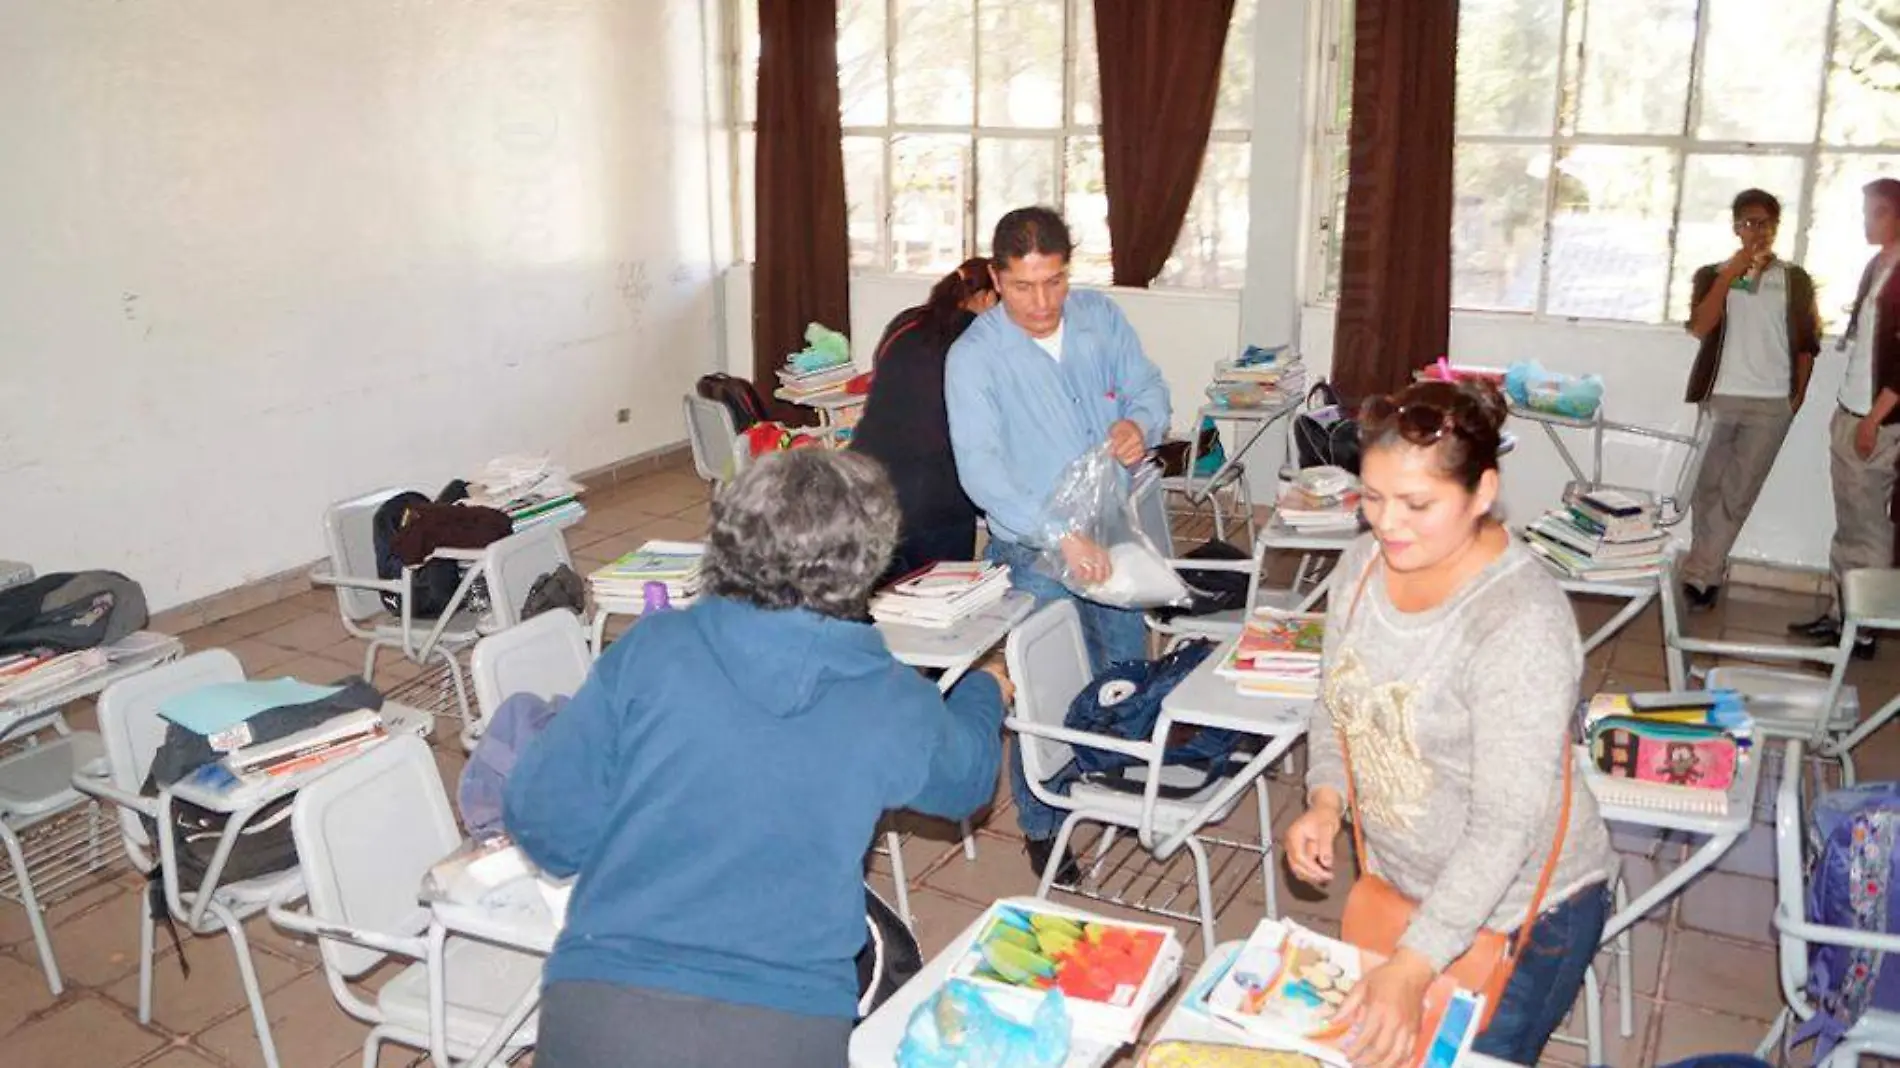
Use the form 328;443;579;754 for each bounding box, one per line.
1332;0;1457;401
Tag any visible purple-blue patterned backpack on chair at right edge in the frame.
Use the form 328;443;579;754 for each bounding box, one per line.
1784;772;1900;1064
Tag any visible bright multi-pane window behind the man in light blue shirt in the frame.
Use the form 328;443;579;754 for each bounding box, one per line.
732;0;1256;289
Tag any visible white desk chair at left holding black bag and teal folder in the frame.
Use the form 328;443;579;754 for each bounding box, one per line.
72;650;300;1068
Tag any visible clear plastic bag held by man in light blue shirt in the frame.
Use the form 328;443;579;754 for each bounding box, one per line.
1037;443;1191;608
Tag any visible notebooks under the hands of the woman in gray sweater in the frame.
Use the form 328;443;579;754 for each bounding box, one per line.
1188;920;1484;1068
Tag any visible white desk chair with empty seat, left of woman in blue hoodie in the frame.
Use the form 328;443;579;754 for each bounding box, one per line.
270;737;543;1068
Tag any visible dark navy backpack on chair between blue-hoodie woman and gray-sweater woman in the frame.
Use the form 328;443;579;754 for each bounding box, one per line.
1062;639;1241;800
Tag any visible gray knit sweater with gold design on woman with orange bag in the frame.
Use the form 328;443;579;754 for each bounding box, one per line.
1307;536;1613;969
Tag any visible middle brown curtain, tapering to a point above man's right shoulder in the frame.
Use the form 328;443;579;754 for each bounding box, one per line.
1094;0;1246;287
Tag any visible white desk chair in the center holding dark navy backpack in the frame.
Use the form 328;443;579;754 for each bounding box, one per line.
1003;599;1279;954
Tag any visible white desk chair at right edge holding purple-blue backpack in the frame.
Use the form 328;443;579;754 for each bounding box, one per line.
1756;739;1900;1068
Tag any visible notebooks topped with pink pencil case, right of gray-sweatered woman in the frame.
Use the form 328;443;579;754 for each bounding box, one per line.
1581;690;1754;815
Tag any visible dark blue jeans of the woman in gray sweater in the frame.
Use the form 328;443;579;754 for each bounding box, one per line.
1471;884;1609;1064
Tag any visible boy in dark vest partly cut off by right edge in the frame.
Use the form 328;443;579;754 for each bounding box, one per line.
1788;179;1900;659
